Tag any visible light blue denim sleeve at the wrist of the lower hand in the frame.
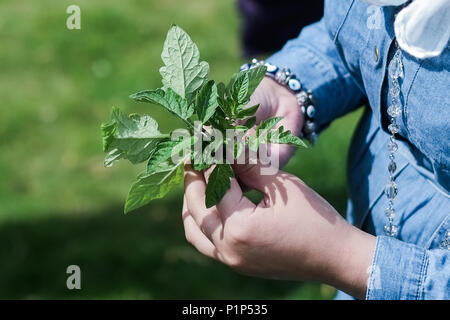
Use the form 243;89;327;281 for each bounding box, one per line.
366;236;450;300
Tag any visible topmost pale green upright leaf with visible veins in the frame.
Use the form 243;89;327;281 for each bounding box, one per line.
159;25;209;101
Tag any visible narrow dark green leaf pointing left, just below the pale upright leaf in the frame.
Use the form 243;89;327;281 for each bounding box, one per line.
130;88;194;120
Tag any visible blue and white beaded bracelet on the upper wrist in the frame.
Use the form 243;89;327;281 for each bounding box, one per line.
240;59;317;145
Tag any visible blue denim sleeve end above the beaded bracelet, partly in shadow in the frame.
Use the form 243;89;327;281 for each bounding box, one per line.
267;19;364;131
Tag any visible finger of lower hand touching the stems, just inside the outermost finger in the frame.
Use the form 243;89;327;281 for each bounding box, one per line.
184;166;222;243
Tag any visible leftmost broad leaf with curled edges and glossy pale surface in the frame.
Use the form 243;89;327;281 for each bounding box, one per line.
102;108;169;167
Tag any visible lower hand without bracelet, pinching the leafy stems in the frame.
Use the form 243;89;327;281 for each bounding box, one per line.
183;166;375;298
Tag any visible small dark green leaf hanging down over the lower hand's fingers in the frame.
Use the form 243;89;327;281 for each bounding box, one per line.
205;164;234;208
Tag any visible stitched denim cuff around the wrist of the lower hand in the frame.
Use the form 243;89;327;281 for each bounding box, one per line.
366;236;428;300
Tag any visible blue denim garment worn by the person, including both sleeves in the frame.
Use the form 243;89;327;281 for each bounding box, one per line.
268;0;450;299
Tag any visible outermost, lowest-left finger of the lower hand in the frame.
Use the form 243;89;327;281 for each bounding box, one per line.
182;198;218;260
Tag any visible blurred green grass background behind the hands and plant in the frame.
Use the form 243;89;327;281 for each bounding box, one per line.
0;0;359;299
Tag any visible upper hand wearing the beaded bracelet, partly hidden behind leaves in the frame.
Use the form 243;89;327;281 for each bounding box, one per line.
243;77;303;168
